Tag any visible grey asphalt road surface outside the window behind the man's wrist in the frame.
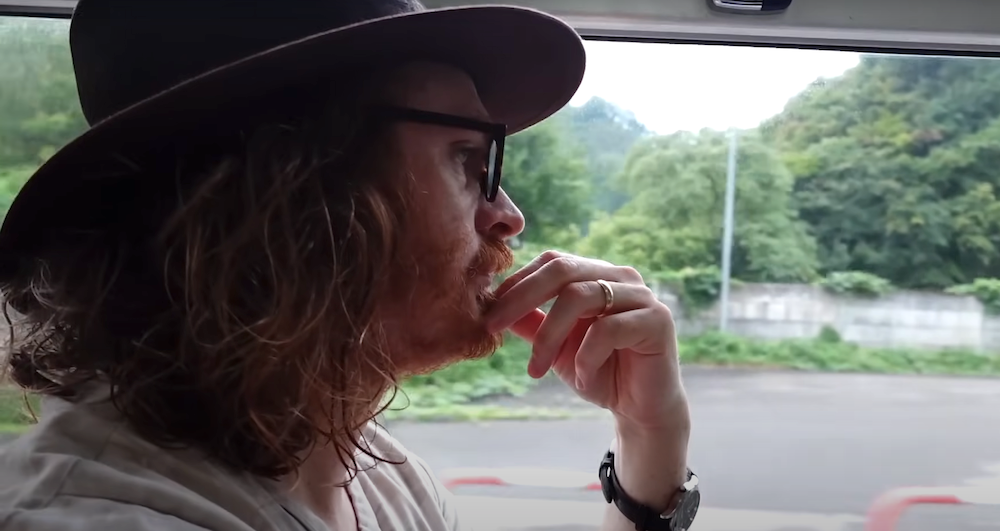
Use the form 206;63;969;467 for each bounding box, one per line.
389;369;1000;531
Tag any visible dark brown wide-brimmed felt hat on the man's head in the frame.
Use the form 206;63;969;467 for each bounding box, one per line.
0;0;586;280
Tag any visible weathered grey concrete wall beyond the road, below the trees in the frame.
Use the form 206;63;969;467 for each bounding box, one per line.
659;284;1000;352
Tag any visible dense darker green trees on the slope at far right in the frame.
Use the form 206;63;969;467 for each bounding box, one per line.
763;56;1000;288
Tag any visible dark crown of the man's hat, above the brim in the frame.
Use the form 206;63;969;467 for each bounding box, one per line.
70;0;425;125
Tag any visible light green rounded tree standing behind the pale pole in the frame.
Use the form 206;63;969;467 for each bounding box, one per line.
583;130;816;282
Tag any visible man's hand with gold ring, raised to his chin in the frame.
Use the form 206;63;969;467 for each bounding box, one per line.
487;251;689;434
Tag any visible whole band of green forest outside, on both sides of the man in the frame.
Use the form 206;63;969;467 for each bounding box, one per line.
0;18;1000;300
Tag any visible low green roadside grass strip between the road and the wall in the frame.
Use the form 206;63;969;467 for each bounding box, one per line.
0;330;1000;433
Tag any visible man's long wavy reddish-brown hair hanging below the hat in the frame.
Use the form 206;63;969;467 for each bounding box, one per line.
0;77;411;478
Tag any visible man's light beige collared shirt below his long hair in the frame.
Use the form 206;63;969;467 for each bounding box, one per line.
0;386;460;531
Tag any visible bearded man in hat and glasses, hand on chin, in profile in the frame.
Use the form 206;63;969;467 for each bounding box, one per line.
0;0;697;531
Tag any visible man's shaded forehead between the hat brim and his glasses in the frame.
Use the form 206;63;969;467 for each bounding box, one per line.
378;62;489;120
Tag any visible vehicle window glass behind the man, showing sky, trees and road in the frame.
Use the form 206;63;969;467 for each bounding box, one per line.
0;13;1000;531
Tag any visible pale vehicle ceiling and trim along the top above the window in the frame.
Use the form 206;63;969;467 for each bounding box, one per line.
0;0;1000;55
